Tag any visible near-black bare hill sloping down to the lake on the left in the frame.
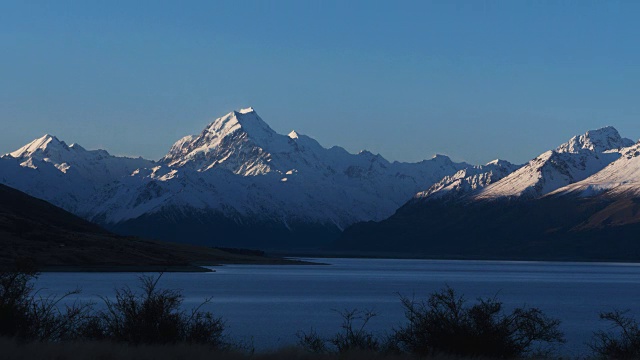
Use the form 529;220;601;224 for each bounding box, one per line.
0;185;304;271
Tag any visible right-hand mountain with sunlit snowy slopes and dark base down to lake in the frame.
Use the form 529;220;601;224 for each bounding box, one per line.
333;127;640;261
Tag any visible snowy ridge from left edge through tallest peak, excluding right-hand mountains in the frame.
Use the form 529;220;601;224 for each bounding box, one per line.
0;108;469;242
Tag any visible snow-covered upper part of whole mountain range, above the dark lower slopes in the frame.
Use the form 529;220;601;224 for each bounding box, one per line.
0;108;640;248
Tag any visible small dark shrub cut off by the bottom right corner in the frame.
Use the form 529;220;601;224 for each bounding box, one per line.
589;310;640;359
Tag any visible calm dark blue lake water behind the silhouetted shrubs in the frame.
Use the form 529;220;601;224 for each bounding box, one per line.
37;259;640;355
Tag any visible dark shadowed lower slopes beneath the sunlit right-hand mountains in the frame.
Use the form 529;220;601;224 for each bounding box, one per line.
332;196;640;261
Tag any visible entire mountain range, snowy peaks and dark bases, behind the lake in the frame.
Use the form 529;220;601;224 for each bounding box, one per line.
0;108;640;257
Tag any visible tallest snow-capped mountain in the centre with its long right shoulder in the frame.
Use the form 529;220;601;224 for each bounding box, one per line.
90;108;469;228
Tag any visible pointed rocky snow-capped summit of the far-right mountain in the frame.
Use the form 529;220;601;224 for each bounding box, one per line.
556;126;634;154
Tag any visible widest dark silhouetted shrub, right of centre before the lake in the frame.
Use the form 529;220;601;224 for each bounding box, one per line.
393;287;564;358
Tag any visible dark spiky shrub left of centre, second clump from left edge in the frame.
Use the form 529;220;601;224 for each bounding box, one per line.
91;275;225;348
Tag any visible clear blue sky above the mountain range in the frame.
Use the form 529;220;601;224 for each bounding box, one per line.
0;0;640;163
